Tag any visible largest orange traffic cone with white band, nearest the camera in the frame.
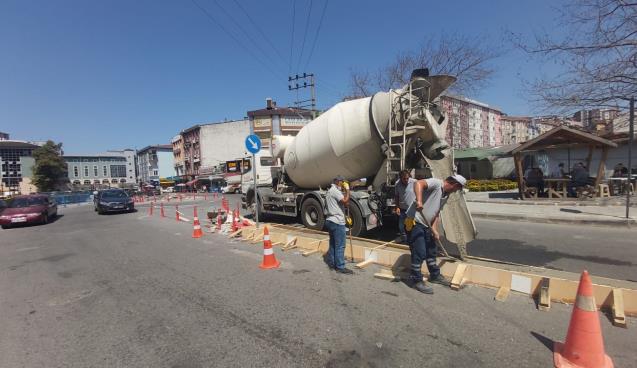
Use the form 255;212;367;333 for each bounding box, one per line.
553;271;613;368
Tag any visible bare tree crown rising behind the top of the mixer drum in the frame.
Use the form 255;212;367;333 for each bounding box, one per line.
350;34;498;97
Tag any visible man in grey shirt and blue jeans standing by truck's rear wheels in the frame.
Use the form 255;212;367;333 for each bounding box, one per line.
325;175;354;275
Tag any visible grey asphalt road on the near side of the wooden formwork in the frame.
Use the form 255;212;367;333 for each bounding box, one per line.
0;204;637;368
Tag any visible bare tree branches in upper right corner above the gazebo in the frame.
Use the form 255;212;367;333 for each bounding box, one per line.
512;0;637;112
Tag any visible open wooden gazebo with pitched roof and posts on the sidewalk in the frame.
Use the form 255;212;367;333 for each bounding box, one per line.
511;126;617;199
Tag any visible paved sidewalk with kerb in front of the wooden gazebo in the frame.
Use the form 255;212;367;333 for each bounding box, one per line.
465;192;637;227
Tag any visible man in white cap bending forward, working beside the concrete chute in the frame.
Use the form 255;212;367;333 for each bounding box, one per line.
409;174;467;294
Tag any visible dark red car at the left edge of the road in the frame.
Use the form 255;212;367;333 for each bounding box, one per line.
0;194;58;229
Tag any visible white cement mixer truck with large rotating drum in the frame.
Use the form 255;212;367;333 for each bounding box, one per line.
242;69;475;249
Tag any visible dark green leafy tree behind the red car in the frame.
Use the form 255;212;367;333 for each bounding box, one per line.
33;141;67;192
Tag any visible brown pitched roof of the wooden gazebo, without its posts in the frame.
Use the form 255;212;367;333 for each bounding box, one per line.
511;126;617;154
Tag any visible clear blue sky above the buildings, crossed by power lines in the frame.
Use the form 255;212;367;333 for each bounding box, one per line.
0;0;555;153
